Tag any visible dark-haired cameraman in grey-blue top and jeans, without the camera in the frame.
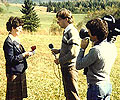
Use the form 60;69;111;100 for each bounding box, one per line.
76;18;117;100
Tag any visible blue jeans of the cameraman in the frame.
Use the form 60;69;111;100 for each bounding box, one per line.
87;83;112;100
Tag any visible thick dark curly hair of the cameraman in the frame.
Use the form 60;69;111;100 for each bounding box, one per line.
86;18;108;41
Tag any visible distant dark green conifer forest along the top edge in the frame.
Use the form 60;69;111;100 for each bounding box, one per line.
39;0;120;14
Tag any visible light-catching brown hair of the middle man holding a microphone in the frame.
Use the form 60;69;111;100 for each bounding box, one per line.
56;8;73;24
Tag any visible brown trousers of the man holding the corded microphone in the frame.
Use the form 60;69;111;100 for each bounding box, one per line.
61;66;80;100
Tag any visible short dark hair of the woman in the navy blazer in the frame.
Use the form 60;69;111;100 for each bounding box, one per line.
6;16;24;31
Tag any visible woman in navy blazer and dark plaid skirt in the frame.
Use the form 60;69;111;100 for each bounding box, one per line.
3;16;33;100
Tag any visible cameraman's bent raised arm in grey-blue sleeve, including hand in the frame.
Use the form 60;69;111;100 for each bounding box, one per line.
76;38;98;70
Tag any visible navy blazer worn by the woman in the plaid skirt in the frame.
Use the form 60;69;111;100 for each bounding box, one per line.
3;36;27;74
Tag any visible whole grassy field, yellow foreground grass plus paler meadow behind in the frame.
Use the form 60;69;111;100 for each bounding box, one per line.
0;3;120;100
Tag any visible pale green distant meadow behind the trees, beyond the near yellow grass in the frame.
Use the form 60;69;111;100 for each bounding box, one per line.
0;4;86;34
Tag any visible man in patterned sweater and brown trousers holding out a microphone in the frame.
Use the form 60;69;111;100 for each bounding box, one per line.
52;8;80;100
